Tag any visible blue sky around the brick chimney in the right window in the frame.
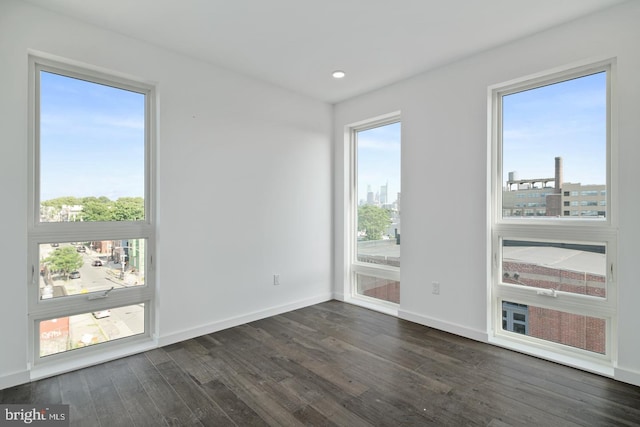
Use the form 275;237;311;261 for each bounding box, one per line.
502;72;607;185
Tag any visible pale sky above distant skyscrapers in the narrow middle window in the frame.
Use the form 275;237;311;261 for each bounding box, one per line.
358;122;401;203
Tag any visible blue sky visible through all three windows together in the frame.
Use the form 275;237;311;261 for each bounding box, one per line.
40;72;606;202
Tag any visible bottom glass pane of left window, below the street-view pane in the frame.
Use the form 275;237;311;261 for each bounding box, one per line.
39;304;145;357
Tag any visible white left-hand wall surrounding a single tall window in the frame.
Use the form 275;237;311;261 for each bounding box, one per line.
0;0;332;389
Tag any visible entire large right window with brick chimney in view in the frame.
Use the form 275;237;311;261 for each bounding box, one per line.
491;62;617;367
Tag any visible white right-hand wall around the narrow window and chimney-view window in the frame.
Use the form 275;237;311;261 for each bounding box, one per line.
334;2;640;385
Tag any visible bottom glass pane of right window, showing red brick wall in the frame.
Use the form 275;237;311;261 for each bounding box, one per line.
502;301;607;354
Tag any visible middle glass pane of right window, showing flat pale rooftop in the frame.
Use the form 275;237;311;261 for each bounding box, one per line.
502;240;607;298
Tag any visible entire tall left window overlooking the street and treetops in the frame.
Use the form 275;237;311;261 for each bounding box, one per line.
28;56;155;364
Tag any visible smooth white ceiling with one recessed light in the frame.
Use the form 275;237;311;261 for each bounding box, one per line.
24;0;626;103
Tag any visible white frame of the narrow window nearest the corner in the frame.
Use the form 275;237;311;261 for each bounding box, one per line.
346;111;402;316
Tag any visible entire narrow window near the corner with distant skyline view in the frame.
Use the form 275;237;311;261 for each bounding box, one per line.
351;115;402;304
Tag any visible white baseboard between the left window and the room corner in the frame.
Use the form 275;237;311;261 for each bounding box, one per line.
158;292;333;347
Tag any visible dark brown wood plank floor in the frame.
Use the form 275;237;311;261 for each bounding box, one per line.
0;301;640;427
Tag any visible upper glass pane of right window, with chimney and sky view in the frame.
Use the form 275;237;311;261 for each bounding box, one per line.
502;72;607;219
